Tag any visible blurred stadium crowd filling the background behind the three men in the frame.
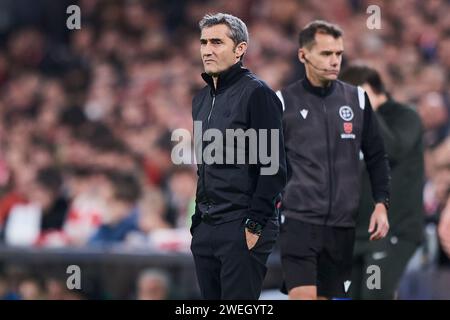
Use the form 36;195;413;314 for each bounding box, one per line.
0;0;450;284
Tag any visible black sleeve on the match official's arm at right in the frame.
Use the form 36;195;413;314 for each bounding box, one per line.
361;93;390;208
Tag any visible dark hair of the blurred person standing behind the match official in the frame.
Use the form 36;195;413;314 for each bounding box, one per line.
340;64;386;94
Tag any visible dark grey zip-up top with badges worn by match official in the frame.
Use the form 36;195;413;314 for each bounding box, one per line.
279;77;389;227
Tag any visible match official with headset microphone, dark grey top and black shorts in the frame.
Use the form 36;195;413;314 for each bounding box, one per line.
278;21;389;299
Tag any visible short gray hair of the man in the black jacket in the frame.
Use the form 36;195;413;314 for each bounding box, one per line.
198;13;248;45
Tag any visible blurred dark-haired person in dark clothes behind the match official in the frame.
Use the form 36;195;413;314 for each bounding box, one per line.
340;65;424;300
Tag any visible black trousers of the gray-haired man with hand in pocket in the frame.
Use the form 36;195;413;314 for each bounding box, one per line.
191;218;279;300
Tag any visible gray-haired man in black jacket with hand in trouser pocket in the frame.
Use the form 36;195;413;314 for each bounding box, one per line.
191;13;286;299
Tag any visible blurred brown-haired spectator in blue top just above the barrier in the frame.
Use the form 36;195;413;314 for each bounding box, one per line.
89;172;141;245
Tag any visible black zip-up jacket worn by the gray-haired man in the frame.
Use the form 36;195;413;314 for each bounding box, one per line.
191;62;286;230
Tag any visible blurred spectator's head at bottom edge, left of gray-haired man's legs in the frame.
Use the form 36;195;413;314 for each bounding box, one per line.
136;269;170;300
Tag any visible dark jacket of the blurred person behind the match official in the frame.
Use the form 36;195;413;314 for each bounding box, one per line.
356;98;425;243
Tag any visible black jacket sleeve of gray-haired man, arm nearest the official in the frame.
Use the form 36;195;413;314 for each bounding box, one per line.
248;86;286;226
